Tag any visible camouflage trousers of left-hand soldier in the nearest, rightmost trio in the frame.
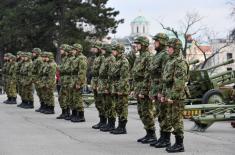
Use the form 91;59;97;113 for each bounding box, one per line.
137;96;155;130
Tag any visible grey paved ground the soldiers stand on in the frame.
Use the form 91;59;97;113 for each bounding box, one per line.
0;95;235;155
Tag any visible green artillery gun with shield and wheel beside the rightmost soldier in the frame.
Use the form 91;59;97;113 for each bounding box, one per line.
184;59;235;118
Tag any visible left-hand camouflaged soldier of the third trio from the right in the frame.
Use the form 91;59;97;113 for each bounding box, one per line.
57;44;71;119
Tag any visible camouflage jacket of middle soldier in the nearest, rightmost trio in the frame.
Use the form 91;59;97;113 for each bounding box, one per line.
148;49;169;96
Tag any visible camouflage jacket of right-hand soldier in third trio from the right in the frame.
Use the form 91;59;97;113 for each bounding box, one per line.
71;53;87;88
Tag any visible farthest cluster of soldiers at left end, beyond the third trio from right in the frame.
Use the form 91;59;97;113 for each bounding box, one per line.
2;48;57;114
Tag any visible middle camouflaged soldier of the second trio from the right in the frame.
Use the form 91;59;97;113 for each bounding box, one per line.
98;44;116;132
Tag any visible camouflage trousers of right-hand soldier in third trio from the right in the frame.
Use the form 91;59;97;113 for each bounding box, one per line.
70;88;84;112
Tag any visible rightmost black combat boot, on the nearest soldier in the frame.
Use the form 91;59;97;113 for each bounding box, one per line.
166;136;184;153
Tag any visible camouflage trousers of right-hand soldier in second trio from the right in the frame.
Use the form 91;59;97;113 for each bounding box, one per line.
114;95;128;121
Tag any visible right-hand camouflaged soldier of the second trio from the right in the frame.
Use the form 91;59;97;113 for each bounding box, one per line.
111;44;130;134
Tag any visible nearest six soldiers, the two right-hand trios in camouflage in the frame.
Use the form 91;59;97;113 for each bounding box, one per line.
91;33;189;152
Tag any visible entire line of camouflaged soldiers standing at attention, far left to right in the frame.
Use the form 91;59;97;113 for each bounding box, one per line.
1;33;188;152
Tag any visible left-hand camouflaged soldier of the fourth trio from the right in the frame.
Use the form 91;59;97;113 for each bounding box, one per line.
32;48;44;112
